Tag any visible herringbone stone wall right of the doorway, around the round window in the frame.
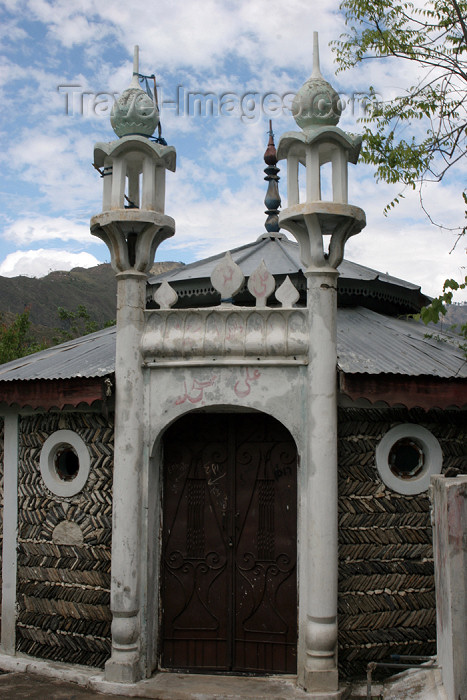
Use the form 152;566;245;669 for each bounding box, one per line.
339;408;467;677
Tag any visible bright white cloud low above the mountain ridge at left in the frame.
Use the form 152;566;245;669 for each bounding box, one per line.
0;248;100;277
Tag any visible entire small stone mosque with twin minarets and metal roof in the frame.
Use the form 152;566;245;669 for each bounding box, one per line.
0;39;467;698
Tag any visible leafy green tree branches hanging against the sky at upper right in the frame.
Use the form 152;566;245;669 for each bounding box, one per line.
331;0;467;230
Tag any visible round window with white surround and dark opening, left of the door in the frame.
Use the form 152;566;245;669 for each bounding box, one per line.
40;430;91;496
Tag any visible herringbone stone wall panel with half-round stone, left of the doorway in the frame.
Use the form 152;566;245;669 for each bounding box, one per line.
16;413;113;667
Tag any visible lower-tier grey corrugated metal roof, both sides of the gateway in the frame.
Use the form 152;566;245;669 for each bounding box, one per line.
0;307;467;382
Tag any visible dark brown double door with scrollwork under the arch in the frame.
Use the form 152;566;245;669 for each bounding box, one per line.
161;413;297;674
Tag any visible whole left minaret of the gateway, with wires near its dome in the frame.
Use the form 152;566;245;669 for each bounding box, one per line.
91;47;175;683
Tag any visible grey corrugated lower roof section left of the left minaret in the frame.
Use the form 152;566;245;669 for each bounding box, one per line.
0;326;116;382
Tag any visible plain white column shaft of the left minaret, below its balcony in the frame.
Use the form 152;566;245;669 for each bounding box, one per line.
105;271;146;683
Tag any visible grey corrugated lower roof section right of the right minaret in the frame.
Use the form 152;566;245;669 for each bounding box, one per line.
337;307;467;379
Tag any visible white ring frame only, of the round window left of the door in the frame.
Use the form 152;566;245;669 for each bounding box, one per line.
40;430;91;497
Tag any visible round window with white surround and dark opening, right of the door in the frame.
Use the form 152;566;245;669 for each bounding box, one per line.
376;423;443;495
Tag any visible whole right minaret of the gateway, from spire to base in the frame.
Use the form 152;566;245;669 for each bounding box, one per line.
277;32;366;698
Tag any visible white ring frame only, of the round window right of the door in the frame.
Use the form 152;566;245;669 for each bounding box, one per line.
376;423;443;496
